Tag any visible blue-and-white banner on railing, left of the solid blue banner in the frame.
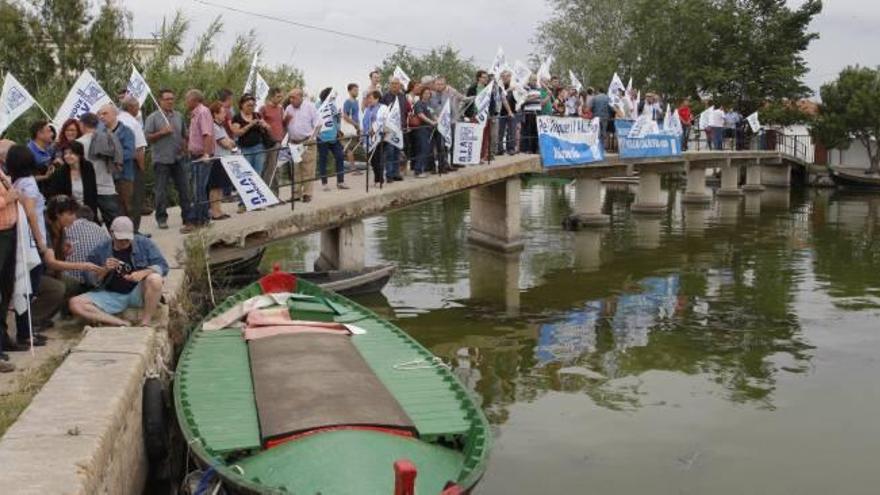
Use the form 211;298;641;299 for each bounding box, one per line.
538;115;605;167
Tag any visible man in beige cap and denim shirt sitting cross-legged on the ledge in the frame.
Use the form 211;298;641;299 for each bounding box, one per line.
70;217;168;327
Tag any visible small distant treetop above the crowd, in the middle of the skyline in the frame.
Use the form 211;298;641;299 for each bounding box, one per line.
374;45;477;91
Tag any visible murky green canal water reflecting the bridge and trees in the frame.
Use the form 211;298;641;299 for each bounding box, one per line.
264;181;880;495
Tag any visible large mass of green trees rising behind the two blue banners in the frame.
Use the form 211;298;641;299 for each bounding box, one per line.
536;0;822;114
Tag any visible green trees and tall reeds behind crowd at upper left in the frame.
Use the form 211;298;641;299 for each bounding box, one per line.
0;0;303;140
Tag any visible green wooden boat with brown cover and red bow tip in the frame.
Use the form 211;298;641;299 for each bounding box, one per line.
174;271;491;495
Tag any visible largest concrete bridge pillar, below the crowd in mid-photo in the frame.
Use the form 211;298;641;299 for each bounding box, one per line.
468;177;523;252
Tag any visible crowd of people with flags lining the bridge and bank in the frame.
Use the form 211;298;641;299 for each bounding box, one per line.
0;63;756;371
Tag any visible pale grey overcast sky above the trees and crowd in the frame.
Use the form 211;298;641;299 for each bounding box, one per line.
123;0;880;98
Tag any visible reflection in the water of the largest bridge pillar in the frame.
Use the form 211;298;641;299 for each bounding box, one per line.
468;246;522;316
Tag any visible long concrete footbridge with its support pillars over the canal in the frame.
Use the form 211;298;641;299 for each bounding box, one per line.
162;151;799;270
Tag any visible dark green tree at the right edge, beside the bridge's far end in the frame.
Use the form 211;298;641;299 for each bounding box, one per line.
813;66;880;174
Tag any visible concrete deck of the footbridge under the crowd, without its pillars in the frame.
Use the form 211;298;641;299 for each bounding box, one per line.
142;151;782;264
